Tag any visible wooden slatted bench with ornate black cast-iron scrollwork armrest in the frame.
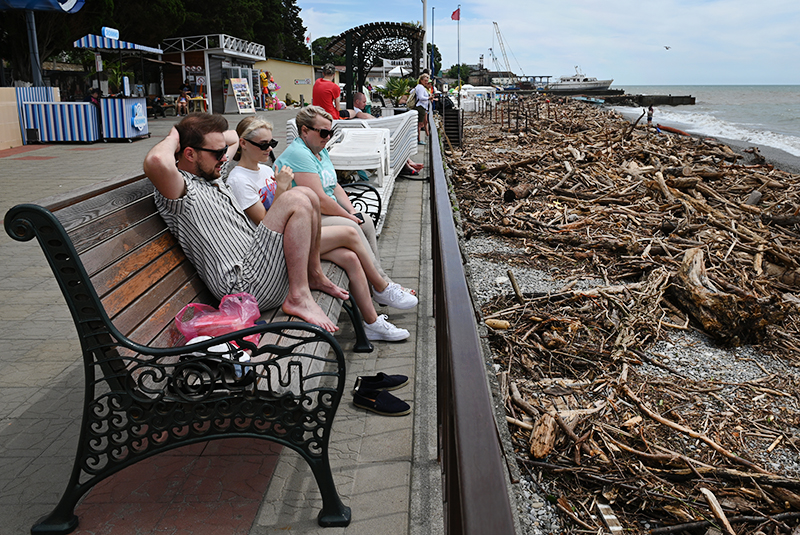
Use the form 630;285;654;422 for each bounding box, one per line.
5;175;372;533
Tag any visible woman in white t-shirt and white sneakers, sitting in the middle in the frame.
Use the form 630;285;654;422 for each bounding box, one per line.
227;116;417;341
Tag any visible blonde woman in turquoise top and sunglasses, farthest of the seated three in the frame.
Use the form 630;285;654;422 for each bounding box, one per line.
275;106;415;294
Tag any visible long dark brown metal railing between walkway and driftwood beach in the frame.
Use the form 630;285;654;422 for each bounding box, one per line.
428;114;514;535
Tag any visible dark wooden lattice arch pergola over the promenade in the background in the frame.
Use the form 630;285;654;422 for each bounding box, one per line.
327;22;425;108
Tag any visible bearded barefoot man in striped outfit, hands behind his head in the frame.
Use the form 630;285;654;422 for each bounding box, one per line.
144;113;348;332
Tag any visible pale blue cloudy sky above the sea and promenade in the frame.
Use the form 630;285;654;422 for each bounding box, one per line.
297;0;800;87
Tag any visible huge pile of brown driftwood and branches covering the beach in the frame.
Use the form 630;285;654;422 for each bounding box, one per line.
446;97;800;534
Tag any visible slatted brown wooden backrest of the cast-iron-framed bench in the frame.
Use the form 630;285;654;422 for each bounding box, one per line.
53;175;216;347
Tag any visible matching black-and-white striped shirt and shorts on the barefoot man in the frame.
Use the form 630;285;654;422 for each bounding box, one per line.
155;170;289;310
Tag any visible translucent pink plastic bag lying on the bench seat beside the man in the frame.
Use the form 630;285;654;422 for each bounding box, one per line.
175;293;261;343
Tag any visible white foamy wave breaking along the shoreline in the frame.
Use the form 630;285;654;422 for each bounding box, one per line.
614;106;800;156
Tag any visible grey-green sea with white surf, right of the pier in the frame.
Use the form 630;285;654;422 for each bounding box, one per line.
612;85;800;157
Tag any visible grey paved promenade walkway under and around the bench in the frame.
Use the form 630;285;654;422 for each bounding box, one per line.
0;110;443;535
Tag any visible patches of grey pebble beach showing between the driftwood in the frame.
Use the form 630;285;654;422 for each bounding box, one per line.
446;97;800;535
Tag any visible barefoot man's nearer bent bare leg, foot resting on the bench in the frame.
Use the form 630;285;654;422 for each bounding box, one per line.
262;189;338;332
